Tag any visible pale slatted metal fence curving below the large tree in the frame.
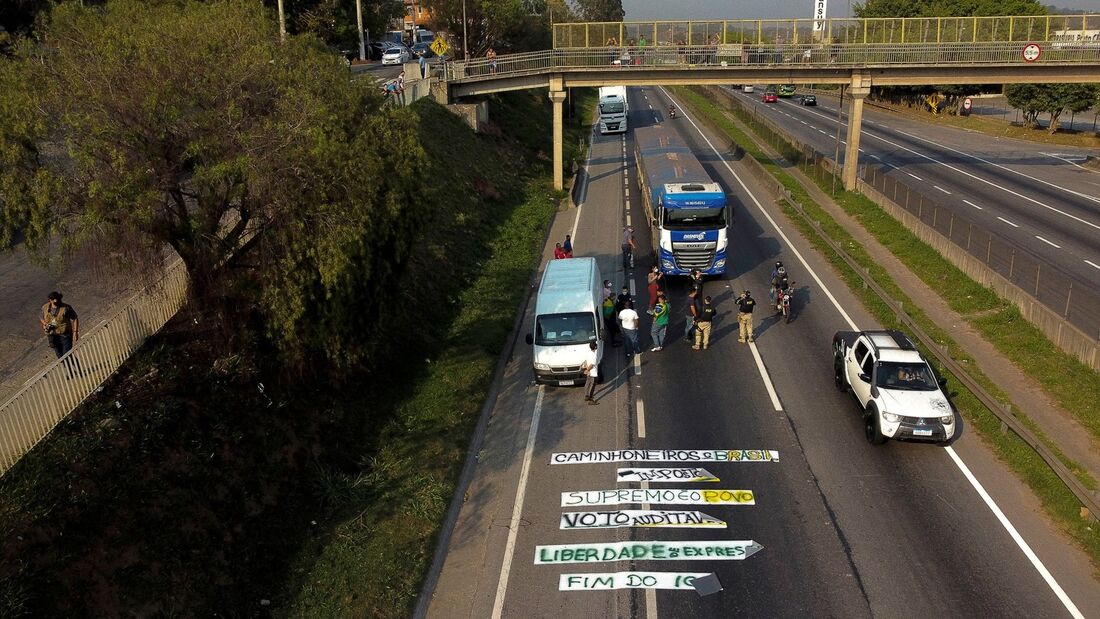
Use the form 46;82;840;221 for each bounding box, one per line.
0;258;188;474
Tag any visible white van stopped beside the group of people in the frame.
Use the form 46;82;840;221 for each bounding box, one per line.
527;258;604;385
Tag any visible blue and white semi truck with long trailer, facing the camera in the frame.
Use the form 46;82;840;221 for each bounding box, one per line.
634;124;732;275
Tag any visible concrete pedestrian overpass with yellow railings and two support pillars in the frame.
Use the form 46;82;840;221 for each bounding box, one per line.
442;14;1100;189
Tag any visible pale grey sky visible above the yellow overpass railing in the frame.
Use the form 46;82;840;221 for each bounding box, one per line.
623;0;1100;21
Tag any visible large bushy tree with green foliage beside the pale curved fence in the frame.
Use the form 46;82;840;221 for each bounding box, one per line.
0;0;425;363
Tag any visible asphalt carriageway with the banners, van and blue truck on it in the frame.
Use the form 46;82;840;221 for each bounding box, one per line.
427;88;1100;619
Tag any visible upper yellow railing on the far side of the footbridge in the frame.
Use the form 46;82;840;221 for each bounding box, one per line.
553;14;1100;49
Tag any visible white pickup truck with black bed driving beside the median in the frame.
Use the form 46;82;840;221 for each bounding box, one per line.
833;331;958;445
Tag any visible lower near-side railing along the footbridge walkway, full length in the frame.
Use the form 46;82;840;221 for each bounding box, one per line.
444;41;1100;81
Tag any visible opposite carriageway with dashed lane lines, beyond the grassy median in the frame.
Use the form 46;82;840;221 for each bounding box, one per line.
732;88;1100;305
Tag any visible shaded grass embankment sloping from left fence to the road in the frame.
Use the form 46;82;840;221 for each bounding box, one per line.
0;90;593;617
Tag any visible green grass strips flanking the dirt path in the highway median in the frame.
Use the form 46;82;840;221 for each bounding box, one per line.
677;88;1100;567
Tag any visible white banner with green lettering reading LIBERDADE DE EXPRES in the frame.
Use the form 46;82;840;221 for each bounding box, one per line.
535;540;763;565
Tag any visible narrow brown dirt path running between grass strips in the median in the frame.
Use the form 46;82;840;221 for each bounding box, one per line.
712;102;1100;495
